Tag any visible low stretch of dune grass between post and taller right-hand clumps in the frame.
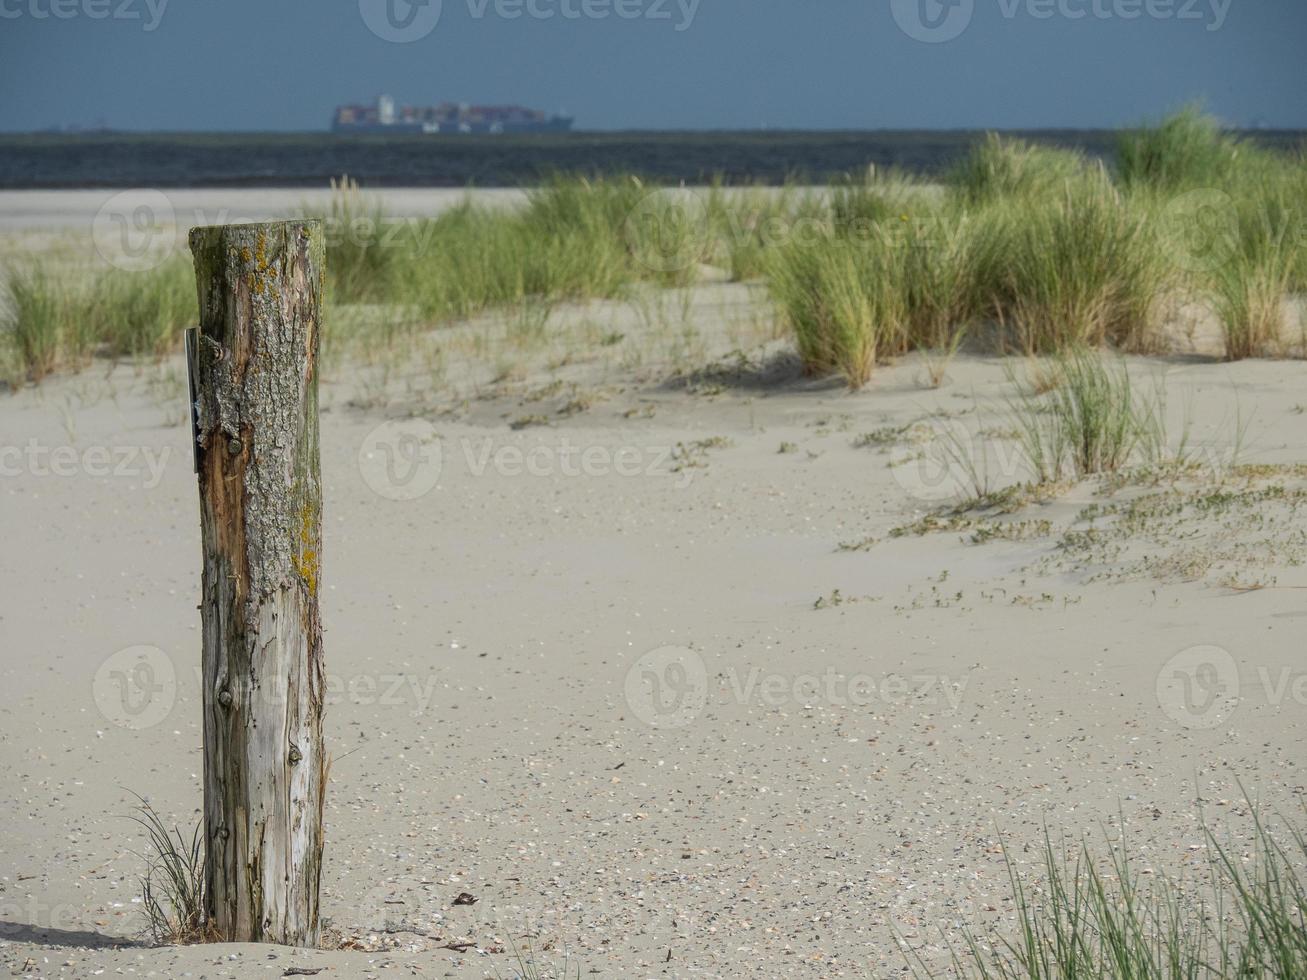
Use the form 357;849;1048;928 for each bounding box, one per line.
311;175;762;371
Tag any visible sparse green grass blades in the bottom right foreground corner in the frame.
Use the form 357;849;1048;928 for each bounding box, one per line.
906;806;1307;980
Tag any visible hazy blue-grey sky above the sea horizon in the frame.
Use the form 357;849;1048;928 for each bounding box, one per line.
0;0;1307;131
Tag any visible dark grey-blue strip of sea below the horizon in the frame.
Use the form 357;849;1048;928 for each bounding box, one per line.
0;129;1307;189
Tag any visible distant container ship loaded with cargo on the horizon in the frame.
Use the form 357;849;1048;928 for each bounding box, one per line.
331;95;572;133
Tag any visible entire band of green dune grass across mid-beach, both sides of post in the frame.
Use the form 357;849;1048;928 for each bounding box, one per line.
0;116;1307;387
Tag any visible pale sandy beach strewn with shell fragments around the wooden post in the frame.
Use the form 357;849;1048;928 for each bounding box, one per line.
0;191;1307;979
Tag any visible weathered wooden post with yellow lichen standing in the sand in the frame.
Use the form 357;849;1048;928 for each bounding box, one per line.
191;221;327;946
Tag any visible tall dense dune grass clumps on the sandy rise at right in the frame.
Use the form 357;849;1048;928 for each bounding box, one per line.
766;110;1307;387
